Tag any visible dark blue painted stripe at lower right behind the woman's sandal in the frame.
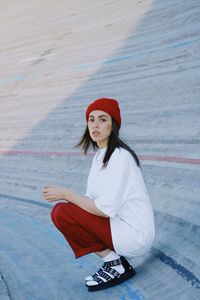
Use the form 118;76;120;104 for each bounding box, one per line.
152;248;200;289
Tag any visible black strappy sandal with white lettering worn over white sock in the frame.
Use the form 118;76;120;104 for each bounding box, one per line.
85;256;136;292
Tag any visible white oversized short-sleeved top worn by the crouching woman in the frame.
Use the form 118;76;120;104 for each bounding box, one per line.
86;148;155;257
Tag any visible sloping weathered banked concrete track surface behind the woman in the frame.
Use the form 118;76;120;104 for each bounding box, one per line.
0;0;200;300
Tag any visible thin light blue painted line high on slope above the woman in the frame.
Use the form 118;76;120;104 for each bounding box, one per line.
0;38;200;83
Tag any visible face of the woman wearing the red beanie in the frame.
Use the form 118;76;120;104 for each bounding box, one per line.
88;110;112;149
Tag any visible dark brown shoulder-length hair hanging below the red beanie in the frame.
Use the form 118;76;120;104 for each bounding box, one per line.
76;118;140;167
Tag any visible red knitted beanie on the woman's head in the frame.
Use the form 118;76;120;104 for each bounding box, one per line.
86;98;121;128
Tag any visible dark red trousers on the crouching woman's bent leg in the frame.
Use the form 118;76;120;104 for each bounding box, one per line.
51;202;114;258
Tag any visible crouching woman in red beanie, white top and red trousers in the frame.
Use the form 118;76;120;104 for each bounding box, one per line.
43;98;154;291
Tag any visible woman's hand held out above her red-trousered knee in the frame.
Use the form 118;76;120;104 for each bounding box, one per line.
42;185;66;202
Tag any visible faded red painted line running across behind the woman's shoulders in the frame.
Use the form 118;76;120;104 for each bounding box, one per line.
0;150;200;165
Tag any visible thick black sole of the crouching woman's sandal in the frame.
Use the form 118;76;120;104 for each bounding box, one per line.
87;269;136;292
